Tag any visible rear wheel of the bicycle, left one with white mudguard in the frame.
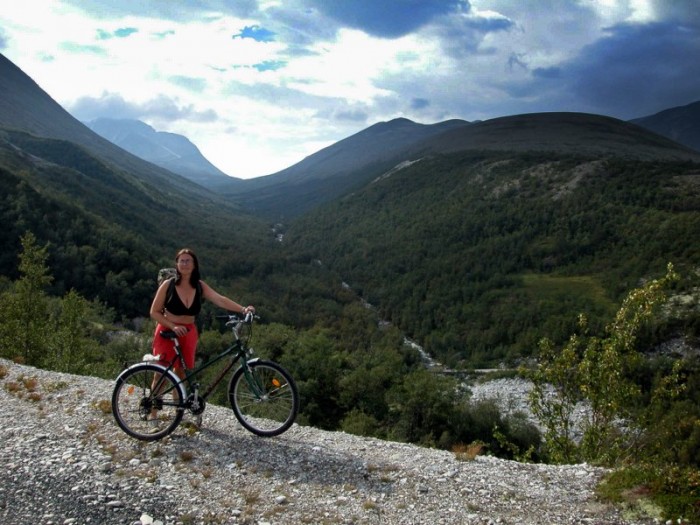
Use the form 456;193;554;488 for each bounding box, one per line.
112;363;185;441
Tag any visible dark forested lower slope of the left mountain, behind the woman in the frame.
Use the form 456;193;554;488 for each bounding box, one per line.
0;130;292;319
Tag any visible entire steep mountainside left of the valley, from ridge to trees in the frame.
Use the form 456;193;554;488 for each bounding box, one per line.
0;55;270;316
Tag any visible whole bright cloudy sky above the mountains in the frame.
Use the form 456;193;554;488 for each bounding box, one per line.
0;0;700;178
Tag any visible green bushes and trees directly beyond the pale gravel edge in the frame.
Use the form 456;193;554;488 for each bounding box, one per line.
0;233;700;523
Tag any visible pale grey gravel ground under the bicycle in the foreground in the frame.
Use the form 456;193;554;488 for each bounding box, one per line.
0;360;652;525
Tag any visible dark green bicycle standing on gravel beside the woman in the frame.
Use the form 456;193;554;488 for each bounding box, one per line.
112;313;299;441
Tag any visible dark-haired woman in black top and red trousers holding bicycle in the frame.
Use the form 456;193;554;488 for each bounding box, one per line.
151;248;255;377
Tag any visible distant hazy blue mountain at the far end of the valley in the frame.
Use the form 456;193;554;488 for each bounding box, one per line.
85;118;228;187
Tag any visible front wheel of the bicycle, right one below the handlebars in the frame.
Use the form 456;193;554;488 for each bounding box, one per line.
228;360;299;437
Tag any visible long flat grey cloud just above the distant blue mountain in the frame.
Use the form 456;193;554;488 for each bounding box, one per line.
68;93;217;122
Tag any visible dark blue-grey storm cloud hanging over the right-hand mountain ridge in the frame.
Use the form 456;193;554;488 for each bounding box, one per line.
493;17;700;120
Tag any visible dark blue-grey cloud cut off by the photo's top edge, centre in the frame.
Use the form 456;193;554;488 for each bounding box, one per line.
304;0;469;38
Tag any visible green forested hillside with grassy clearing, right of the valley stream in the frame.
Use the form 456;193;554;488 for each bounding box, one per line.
286;152;700;366
